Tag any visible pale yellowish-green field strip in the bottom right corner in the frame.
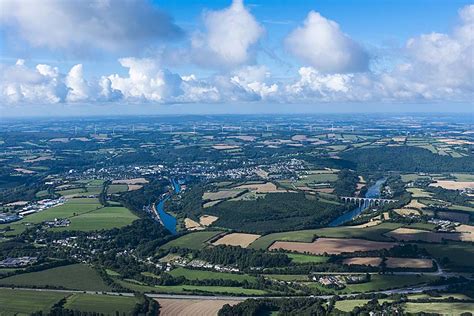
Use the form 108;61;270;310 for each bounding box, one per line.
404;302;474;315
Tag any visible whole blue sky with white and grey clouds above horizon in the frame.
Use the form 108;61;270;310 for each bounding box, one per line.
0;0;474;117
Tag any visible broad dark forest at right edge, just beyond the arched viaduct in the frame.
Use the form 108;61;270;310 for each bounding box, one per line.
341;146;474;172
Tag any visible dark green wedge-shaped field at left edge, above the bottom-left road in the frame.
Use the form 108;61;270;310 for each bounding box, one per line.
0;264;110;291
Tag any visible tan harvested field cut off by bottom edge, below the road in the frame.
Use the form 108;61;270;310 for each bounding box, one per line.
157;298;241;316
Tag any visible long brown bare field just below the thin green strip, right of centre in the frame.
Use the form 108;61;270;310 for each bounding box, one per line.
269;238;397;255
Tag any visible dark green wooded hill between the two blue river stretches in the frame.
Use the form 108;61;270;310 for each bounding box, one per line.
206;193;350;234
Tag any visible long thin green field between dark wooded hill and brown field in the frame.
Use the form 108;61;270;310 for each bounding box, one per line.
250;223;402;249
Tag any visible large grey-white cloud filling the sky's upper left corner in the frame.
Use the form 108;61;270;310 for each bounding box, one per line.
0;0;182;54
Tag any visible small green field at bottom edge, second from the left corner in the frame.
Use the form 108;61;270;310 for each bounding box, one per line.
64;293;137;315
